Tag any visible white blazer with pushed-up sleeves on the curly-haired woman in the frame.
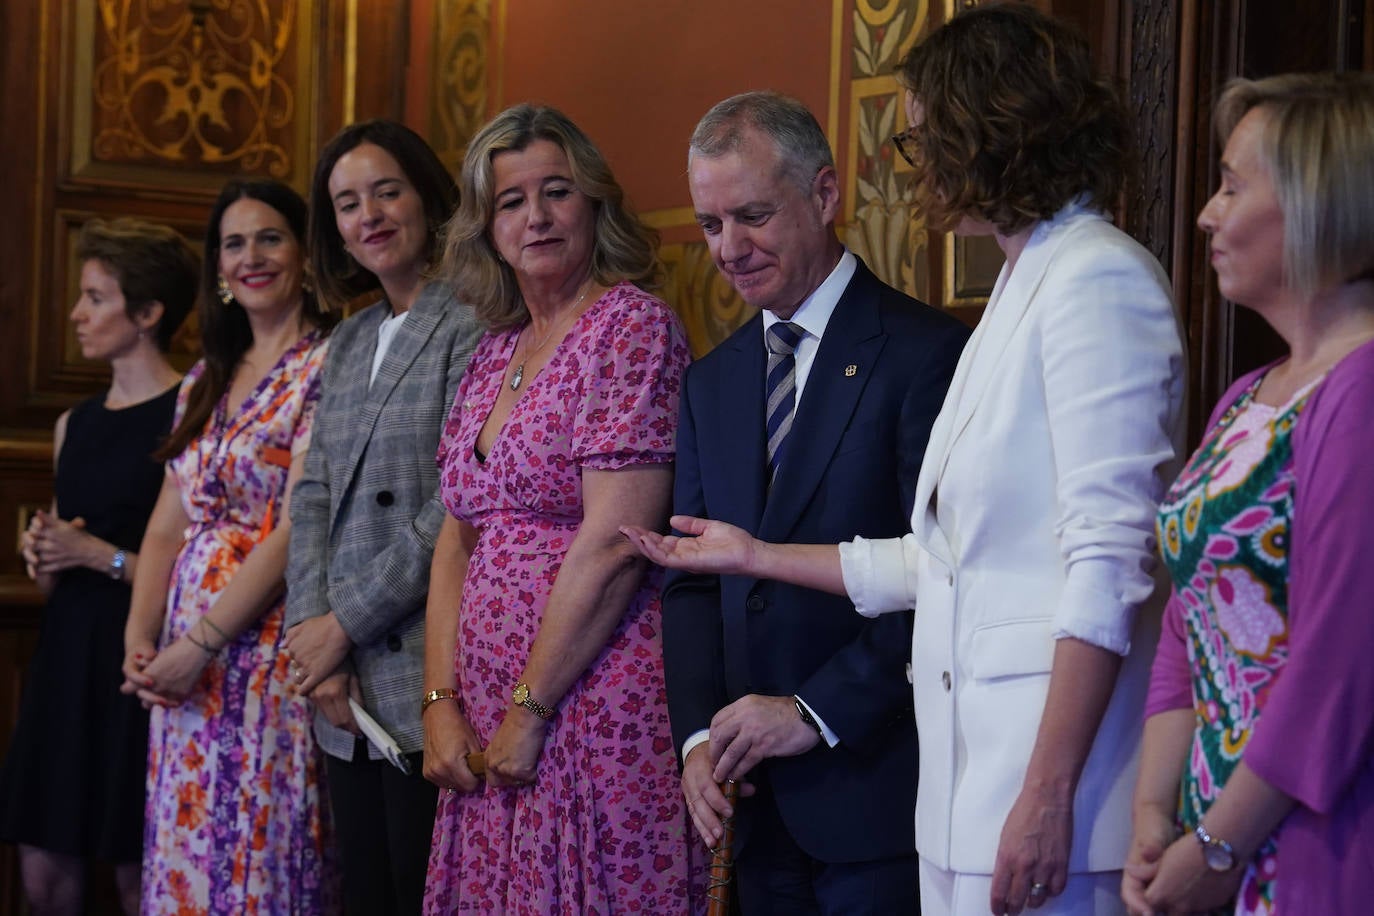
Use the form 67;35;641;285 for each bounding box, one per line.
841;205;1184;873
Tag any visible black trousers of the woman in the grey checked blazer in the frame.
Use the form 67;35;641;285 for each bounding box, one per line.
324;739;438;916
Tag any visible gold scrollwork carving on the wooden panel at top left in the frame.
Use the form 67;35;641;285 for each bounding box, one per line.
71;0;313;190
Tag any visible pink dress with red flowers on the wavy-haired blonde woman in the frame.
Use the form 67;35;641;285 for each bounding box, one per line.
425;283;705;916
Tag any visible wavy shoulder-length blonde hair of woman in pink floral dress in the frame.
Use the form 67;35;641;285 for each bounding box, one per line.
440;104;662;330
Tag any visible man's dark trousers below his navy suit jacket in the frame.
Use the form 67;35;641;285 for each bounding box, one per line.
735;780;921;916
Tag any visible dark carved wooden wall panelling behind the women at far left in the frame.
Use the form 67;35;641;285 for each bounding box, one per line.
0;0;408;916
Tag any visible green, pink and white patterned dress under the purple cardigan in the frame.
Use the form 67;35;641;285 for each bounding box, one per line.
1158;376;1316;915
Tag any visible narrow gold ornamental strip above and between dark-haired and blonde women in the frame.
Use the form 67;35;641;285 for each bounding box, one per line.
429;0;492;172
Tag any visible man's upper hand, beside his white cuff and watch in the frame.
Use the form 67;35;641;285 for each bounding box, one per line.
710;694;820;783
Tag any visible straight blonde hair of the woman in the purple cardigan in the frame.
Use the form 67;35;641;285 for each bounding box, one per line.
1215;73;1374;297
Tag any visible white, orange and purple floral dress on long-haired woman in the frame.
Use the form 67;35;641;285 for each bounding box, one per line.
143;332;338;916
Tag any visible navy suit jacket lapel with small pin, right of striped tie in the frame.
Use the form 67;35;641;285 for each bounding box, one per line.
758;262;888;540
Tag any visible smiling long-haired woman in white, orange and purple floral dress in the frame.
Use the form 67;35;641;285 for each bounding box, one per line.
124;181;338;915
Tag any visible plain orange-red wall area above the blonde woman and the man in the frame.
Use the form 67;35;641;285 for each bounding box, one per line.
491;0;834;241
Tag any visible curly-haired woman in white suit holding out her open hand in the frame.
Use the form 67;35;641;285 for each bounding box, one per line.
627;4;1183;913
